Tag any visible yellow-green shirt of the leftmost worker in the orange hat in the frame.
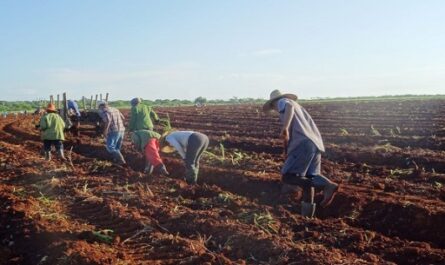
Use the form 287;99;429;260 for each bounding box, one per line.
40;113;65;141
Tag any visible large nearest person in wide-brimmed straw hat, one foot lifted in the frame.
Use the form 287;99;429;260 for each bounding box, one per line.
263;90;338;217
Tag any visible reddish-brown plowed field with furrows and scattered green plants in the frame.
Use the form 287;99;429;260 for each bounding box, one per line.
0;100;445;264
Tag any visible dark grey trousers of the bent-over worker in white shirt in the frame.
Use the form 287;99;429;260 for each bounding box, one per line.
184;132;209;184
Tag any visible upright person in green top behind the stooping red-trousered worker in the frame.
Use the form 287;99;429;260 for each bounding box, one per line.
129;98;159;132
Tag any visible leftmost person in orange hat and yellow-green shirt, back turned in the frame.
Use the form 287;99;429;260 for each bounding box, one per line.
39;103;65;161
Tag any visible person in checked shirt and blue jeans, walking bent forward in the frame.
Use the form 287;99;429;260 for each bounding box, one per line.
99;101;126;165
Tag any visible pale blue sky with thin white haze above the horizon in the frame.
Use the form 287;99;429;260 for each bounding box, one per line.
0;0;445;100
